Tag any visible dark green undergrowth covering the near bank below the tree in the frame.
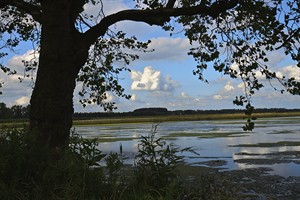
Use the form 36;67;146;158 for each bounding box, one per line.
0;124;236;200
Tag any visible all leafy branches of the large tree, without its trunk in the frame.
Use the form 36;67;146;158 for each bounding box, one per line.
0;0;300;126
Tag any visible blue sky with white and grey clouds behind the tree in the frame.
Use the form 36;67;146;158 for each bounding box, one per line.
0;0;300;112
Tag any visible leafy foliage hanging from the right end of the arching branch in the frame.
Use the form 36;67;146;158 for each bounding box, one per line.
178;1;299;105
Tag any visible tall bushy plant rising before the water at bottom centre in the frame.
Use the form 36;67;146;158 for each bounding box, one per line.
135;123;196;199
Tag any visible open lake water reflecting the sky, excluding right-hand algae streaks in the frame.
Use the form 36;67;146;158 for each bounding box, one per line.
75;117;300;176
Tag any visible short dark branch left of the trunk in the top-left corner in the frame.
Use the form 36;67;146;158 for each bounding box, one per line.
0;0;42;23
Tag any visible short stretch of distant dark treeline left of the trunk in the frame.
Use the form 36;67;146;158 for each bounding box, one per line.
0;103;30;120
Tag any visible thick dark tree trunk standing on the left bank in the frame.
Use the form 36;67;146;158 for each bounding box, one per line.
30;0;88;147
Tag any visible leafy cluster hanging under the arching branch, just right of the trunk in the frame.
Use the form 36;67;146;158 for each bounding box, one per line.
77;32;150;110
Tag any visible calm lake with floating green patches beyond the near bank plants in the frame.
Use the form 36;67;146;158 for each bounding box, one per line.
75;117;300;177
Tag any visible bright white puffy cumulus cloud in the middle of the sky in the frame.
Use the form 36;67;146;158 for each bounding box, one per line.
131;66;178;92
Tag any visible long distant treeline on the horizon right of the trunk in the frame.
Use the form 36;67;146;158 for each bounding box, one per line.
74;108;300;119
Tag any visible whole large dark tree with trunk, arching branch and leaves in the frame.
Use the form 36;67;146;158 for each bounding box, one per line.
0;0;300;147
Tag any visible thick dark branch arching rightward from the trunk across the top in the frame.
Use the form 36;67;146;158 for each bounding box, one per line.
84;0;239;44
